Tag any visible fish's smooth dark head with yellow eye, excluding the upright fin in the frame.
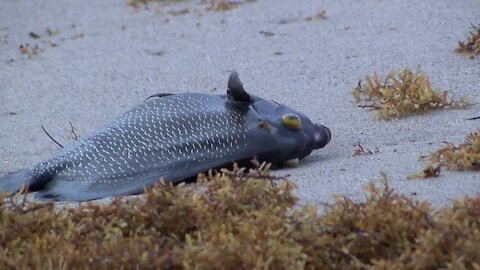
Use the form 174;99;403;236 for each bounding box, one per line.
250;96;332;166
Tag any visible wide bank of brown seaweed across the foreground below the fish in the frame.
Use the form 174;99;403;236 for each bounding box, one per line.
0;164;480;269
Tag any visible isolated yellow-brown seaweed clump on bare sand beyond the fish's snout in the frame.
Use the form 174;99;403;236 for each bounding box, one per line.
351;68;468;119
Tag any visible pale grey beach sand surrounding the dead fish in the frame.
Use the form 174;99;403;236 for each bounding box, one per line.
0;0;480;205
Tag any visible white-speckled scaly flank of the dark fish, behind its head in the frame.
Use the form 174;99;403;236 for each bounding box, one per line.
33;94;249;183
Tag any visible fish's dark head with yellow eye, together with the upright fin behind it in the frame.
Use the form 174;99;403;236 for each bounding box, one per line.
226;72;332;166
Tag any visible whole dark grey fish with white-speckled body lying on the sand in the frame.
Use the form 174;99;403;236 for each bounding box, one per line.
0;72;331;201
